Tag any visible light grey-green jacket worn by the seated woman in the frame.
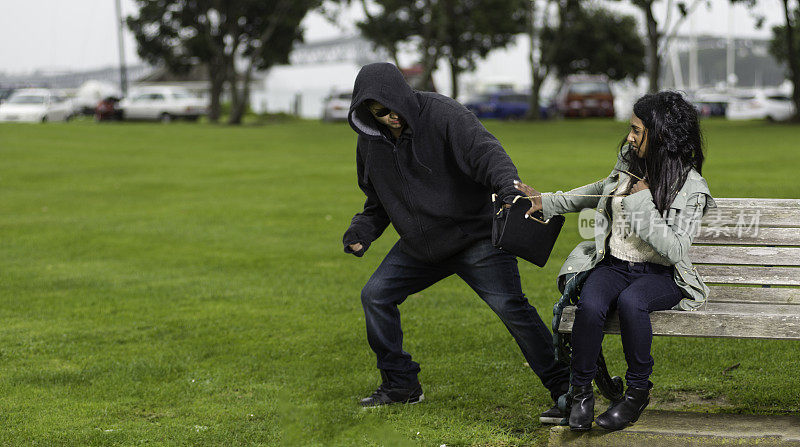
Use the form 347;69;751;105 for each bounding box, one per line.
542;148;716;310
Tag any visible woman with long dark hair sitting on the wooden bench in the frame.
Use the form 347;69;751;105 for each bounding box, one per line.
518;92;716;430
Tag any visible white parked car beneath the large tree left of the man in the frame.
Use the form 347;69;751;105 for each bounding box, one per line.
119;87;207;122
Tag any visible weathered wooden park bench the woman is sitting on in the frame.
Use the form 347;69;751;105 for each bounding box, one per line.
553;199;800;400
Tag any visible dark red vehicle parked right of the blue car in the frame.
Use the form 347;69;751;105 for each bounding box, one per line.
554;75;614;117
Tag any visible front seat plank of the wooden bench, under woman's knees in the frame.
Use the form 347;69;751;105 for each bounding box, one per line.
559;306;800;340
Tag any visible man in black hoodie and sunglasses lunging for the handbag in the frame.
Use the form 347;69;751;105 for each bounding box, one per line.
343;63;569;418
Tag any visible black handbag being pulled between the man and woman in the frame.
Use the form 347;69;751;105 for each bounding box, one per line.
492;194;565;267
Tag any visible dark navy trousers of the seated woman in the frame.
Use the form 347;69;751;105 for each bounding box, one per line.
572;256;682;389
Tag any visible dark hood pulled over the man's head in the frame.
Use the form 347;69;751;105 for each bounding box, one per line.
347;62;420;137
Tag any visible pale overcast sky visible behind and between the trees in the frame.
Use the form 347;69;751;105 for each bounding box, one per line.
0;0;782;73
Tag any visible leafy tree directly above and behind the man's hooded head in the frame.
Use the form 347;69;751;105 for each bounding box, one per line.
359;0;529;97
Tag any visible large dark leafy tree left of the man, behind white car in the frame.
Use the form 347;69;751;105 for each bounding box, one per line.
127;0;320;124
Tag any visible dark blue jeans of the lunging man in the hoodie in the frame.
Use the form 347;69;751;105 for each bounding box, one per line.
361;240;569;397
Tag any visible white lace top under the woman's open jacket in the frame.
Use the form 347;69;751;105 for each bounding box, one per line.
608;177;672;265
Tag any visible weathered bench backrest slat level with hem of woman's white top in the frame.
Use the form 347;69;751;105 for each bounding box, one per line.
689;245;800;266
